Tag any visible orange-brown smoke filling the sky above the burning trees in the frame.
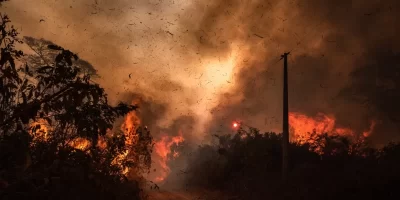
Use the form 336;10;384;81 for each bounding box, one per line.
1;0;400;147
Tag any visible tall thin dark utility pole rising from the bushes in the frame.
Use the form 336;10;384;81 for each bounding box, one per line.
281;52;290;182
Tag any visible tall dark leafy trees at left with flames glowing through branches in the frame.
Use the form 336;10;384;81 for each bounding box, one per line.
0;3;152;200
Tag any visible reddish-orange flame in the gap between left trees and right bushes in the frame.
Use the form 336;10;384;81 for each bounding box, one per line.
154;134;185;183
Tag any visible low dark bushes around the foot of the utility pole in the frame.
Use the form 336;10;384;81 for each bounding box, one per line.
180;129;400;199
